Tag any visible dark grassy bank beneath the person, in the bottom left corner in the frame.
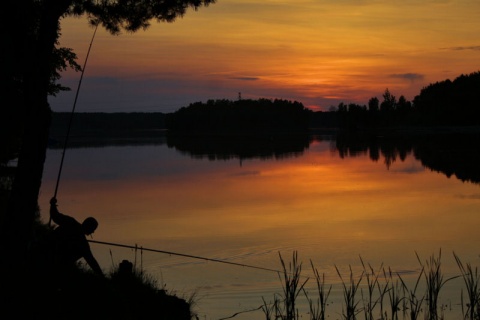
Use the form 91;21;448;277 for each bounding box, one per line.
0;208;195;320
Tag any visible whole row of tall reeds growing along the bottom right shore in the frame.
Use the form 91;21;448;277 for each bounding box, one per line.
262;250;480;320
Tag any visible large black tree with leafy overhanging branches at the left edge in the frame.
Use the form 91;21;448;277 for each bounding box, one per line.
0;0;214;310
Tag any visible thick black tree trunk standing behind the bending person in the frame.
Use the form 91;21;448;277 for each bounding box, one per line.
0;0;68;312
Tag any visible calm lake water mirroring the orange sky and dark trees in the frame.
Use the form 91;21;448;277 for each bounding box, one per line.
40;131;480;319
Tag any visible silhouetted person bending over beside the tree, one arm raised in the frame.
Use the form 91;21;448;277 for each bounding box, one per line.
50;197;104;277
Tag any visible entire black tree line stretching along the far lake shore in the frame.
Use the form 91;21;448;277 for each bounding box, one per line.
10;72;480;164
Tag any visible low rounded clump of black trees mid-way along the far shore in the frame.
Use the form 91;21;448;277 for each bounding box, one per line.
165;99;312;133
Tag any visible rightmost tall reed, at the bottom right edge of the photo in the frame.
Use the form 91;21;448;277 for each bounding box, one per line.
453;252;480;320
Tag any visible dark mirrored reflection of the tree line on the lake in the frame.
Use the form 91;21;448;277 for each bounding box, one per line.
46;115;480;183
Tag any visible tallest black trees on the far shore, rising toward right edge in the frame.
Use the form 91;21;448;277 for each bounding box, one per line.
330;72;480;129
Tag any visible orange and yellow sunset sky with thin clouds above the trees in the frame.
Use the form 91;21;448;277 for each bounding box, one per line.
50;0;480;112
